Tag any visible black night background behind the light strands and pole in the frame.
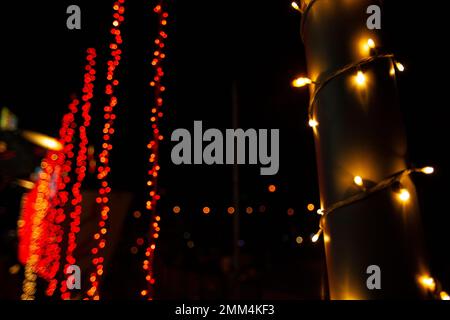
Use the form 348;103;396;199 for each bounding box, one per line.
0;0;450;299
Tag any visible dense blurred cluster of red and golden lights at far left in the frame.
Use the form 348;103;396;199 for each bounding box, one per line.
18;98;79;299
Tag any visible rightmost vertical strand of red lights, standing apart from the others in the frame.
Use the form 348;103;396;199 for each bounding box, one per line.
141;2;169;300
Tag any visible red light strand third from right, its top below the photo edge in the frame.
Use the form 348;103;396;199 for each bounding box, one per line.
60;48;96;299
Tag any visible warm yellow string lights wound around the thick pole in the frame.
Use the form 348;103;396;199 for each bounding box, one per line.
292;0;450;300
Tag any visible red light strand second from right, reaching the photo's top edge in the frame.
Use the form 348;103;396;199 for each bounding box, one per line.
86;0;125;300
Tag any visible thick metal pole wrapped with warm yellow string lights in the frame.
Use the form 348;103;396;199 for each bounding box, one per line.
302;0;427;299
